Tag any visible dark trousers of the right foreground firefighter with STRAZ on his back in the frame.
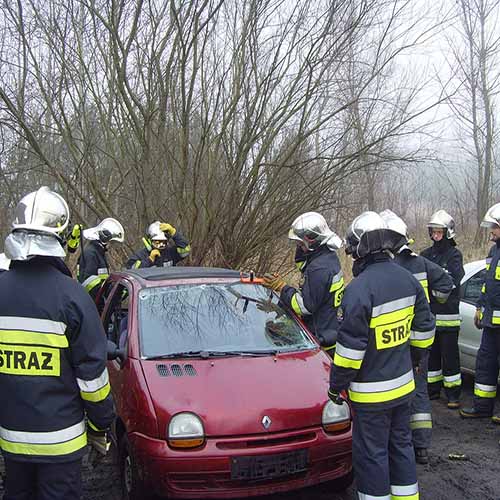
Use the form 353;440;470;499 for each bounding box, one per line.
352;401;419;500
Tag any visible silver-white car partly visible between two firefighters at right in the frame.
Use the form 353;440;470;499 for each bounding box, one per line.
458;259;486;373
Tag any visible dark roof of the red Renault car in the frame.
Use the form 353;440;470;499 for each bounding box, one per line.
117;266;246;286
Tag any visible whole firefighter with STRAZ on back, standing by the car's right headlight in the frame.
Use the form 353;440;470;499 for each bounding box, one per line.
329;212;435;500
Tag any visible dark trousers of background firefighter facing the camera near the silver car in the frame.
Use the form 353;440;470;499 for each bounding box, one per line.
427;328;462;401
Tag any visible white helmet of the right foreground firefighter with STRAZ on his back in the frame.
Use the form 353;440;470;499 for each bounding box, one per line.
345;211;401;259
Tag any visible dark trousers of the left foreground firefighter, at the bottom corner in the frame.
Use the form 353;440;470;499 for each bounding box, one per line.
3;457;82;500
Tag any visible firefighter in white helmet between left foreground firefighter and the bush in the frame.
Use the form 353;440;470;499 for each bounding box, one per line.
78;217;124;300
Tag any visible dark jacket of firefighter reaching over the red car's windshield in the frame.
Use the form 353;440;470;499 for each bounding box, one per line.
280;245;344;348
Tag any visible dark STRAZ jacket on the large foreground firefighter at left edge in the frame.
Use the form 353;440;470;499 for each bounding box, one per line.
0;257;114;462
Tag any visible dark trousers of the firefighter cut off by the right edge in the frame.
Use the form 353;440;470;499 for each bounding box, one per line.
474;328;500;414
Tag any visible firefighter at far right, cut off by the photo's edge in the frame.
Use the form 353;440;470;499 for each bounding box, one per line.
460;203;500;424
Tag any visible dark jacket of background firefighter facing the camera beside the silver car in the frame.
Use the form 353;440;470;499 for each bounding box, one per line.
421;239;465;330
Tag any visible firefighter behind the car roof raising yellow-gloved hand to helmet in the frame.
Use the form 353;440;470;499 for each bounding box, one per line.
126;221;191;269
